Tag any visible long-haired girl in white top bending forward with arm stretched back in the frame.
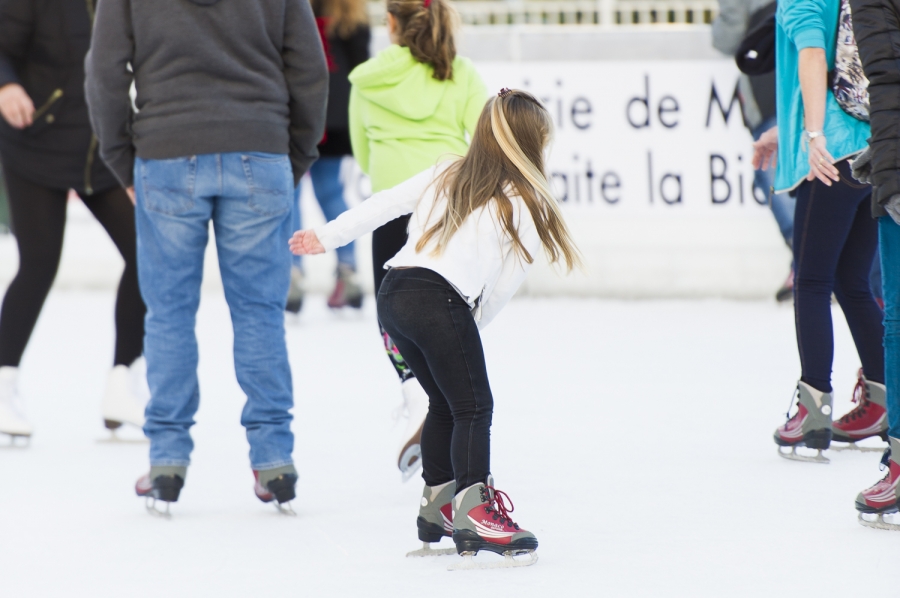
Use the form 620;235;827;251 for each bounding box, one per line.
290;89;578;565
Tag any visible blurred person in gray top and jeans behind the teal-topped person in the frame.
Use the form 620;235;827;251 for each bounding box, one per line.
712;0;797;301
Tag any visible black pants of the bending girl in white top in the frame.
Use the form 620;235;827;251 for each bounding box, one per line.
378;268;494;490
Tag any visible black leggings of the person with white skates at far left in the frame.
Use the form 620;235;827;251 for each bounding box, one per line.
0;169;146;366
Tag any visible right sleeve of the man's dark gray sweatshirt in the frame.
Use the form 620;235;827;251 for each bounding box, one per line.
281;0;328;183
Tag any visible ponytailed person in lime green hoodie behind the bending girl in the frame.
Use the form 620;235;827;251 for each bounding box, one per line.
350;0;487;481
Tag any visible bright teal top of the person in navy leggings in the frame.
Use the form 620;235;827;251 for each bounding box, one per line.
775;0;869;192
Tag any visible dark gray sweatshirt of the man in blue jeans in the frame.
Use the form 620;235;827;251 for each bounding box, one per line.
85;0;328;187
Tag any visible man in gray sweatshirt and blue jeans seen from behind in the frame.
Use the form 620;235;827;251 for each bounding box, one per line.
85;0;328;516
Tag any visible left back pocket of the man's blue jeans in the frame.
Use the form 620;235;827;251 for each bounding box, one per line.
139;156;197;216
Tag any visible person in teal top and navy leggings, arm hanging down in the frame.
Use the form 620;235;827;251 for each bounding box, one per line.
774;0;887;461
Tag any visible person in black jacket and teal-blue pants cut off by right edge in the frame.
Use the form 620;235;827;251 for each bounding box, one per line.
851;0;900;529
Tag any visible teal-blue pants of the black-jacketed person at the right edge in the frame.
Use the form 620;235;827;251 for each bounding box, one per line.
878;216;900;438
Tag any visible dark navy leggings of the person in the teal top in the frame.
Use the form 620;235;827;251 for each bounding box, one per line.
794;160;884;392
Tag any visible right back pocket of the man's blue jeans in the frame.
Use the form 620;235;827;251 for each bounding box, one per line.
241;153;294;216
